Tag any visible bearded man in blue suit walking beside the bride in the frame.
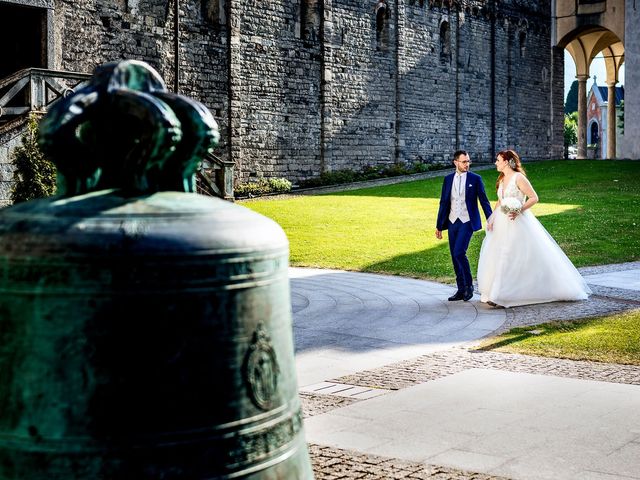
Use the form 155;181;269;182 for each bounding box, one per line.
436;150;491;302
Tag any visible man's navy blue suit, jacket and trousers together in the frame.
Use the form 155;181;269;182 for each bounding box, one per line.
436;172;491;295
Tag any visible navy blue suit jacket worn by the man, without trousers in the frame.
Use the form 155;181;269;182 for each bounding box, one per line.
436;172;491;231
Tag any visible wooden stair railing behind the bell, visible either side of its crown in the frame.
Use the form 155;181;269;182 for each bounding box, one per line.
0;68;234;201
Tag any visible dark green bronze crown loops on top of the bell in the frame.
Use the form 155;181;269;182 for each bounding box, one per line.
39;60;219;196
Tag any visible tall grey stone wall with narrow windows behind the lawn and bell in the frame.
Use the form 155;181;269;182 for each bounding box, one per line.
2;0;563;187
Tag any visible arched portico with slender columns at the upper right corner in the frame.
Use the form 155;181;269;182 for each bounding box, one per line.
553;0;640;158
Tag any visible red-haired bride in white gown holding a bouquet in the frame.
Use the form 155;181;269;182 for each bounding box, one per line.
478;150;591;307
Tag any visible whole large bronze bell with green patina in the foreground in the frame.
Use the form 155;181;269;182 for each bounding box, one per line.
0;61;313;480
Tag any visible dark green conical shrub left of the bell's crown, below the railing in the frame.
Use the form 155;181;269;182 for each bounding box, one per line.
11;114;56;203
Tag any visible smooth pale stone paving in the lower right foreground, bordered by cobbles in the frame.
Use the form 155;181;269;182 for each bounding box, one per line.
305;369;640;480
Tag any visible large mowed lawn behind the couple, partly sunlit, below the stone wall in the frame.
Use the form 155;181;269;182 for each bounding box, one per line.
240;160;640;282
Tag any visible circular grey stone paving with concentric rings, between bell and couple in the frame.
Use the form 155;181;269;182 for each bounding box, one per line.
290;269;506;386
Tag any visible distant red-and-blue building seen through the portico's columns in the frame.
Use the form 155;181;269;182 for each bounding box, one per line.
587;76;624;158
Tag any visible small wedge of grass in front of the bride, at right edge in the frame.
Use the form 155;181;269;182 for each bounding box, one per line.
479;310;640;365
